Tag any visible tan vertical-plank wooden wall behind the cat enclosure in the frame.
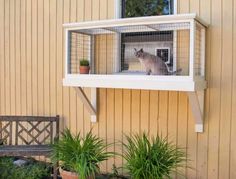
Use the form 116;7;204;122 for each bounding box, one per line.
0;0;236;179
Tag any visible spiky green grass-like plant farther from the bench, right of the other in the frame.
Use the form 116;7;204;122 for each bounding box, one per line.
123;133;186;179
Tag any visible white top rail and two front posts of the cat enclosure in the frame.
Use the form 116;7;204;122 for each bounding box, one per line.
64;14;206;79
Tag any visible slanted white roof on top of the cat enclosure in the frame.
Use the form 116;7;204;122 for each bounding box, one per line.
63;14;207;34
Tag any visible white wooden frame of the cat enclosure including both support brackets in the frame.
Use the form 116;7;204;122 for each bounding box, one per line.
63;12;207;132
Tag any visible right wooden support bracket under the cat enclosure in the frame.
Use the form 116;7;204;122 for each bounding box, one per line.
188;90;204;132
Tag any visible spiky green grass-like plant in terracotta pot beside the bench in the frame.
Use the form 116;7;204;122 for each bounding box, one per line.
52;129;113;179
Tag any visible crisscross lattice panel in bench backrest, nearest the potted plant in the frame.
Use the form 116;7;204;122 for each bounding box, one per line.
16;121;53;145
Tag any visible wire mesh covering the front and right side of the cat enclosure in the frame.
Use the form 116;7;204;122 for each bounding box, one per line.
68;22;202;76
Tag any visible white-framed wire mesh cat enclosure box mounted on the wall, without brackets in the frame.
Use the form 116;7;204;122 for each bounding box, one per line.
63;14;206;91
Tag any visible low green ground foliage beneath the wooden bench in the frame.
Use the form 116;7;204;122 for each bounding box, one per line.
0;157;50;179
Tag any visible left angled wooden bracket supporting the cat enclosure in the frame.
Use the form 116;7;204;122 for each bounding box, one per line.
75;87;97;122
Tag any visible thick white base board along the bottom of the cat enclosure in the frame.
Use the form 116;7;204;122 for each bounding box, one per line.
63;74;206;92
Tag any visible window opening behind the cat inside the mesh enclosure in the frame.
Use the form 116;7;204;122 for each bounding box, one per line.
121;31;173;72
